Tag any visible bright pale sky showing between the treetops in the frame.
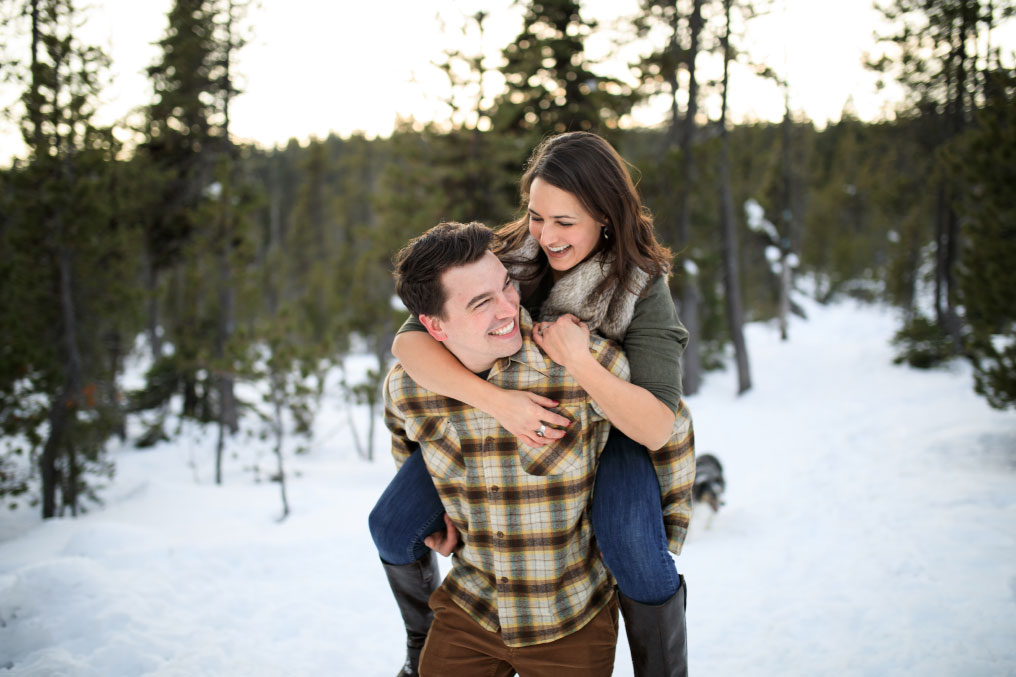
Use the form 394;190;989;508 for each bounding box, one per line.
0;0;959;160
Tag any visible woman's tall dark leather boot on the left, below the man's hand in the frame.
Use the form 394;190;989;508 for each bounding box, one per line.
381;551;441;677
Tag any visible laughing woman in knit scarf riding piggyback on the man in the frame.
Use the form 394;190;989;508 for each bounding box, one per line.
371;132;690;675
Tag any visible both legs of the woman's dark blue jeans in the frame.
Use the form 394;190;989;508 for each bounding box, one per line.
369;429;681;604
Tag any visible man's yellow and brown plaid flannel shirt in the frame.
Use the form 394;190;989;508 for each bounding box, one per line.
384;309;694;647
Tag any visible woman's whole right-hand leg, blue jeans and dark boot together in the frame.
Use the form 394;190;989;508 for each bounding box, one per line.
592;430;688;677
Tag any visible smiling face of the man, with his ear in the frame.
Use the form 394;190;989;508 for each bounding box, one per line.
420;251;522;372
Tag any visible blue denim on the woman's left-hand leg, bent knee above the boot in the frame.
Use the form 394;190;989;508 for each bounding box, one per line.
368;451;445;564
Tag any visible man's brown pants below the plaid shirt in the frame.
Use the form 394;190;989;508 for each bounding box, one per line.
420;588;618;677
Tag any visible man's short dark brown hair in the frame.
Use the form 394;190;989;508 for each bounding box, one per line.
393;222;494;317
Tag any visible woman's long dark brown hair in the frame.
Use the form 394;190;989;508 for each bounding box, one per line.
494;132;673;294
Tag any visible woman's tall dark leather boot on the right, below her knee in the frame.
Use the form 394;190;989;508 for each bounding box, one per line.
618;576;688;677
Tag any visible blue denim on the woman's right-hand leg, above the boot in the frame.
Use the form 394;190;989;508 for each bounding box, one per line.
592;430;681;604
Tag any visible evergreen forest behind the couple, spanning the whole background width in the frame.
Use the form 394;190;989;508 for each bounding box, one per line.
0;0;1016;517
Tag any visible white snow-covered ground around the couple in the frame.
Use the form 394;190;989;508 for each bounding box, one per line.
0;296;1016;677
